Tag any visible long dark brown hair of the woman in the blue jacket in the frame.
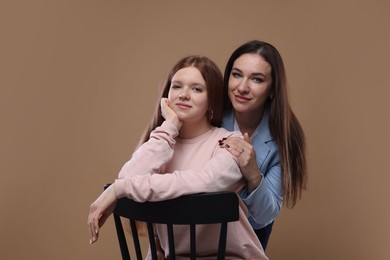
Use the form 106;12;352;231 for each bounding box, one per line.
223;40;307;207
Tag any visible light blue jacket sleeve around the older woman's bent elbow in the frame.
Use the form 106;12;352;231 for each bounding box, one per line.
240;163;283;228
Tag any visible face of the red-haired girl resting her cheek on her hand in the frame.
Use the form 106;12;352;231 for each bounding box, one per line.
168;67;209;123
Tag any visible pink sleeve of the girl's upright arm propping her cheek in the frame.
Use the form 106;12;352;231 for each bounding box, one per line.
118;121;179;179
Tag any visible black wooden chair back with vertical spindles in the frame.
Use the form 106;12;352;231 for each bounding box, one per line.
105;184;239;260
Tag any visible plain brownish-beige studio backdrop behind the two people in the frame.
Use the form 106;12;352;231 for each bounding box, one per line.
0;0;390;260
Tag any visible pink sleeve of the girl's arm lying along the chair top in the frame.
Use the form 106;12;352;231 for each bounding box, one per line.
113;147;244;202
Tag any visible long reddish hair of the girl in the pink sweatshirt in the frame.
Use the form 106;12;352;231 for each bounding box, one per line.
138;55;223;145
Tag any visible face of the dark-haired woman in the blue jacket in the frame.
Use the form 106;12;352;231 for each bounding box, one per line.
228;53;272;113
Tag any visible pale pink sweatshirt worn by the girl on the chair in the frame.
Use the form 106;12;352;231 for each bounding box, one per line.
113;121;268;260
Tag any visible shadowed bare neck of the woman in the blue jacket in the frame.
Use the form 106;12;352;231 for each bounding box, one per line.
234;108;264;136
